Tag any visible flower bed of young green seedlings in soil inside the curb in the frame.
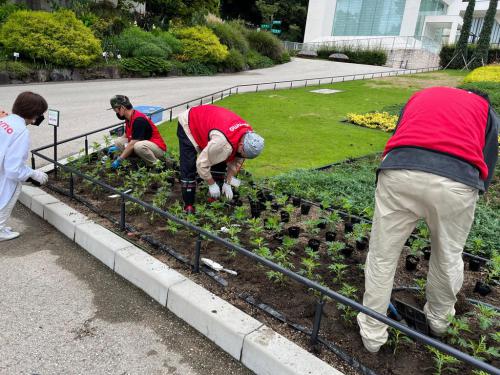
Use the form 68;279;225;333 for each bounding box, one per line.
44;146;499;374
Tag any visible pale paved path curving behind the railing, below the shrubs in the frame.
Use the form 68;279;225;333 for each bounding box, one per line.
0;59;394;164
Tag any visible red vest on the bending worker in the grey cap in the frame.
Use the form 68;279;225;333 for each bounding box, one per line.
189;105;252;161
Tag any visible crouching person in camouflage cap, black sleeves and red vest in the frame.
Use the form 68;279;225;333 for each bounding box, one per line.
109;95;167;169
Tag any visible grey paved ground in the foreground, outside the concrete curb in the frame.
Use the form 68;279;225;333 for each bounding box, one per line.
0;204;251;375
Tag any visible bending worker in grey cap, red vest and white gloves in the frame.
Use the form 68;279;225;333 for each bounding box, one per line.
177;105;264;213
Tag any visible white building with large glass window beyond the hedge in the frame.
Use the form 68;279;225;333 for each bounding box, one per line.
304;0;500;50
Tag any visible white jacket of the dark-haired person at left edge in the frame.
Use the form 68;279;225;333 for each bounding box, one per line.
0;115;33;210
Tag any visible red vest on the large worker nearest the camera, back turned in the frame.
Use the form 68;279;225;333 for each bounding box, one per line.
384;87;489;180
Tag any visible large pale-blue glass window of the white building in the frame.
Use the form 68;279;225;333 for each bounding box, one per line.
332;0;406;36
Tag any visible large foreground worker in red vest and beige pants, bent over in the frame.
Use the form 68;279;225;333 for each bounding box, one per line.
357;87;498;352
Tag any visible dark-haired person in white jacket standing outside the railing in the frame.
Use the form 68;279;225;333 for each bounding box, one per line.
0;91;48;241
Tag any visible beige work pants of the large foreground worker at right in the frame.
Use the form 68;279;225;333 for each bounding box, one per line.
357;170;478;352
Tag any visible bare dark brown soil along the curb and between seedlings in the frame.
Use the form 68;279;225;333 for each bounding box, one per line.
45;167;499;375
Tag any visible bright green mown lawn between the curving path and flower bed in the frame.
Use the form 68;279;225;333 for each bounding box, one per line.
160;72;465;177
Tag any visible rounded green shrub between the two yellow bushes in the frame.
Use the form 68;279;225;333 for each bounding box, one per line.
111;26;172;58
